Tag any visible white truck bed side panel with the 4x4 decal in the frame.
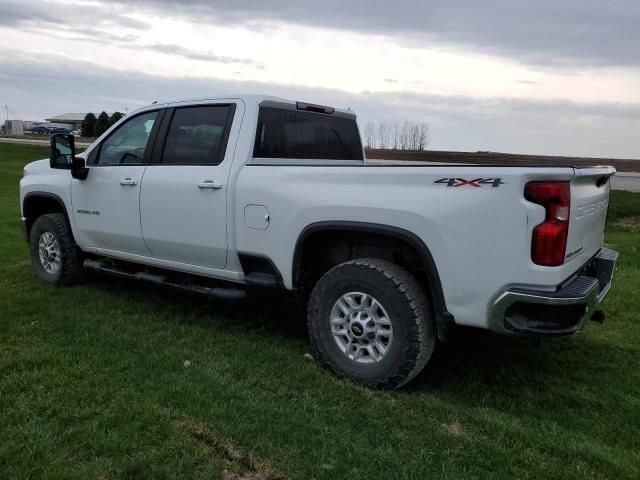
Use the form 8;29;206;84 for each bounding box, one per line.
235;165;582;327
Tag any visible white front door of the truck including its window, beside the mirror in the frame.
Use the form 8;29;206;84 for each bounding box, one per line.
71;111;159;256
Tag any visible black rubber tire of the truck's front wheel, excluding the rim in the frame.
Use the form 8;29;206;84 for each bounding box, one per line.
29;213;85;285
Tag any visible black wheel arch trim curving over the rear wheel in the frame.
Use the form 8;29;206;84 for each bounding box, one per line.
291;221;455;340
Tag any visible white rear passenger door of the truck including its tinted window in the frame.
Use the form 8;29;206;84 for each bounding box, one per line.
140;102;243;268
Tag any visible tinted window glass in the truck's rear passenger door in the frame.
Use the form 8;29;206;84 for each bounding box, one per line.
162;105;234;165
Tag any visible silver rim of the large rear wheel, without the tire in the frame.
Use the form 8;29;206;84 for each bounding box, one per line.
330;292;393;363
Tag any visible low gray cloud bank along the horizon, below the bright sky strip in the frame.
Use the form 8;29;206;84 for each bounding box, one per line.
0;51;640;158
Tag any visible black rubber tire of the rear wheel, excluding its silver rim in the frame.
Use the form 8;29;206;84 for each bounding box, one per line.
308;258;437;389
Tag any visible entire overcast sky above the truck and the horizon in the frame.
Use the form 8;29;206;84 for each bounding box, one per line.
0;0;640;158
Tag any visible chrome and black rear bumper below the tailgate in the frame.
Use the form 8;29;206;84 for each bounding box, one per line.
490;248;618;336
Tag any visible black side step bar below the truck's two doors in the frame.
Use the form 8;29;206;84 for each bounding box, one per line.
83;259;247;301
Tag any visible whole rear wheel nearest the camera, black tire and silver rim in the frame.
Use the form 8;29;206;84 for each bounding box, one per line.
308;258;437;388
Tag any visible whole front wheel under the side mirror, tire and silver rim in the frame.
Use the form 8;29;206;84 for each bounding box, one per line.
29;213;84;285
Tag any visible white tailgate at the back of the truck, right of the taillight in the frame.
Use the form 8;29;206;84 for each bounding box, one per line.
565;167;616;266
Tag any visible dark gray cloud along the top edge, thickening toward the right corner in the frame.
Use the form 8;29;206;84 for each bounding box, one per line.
102;0;640;68
